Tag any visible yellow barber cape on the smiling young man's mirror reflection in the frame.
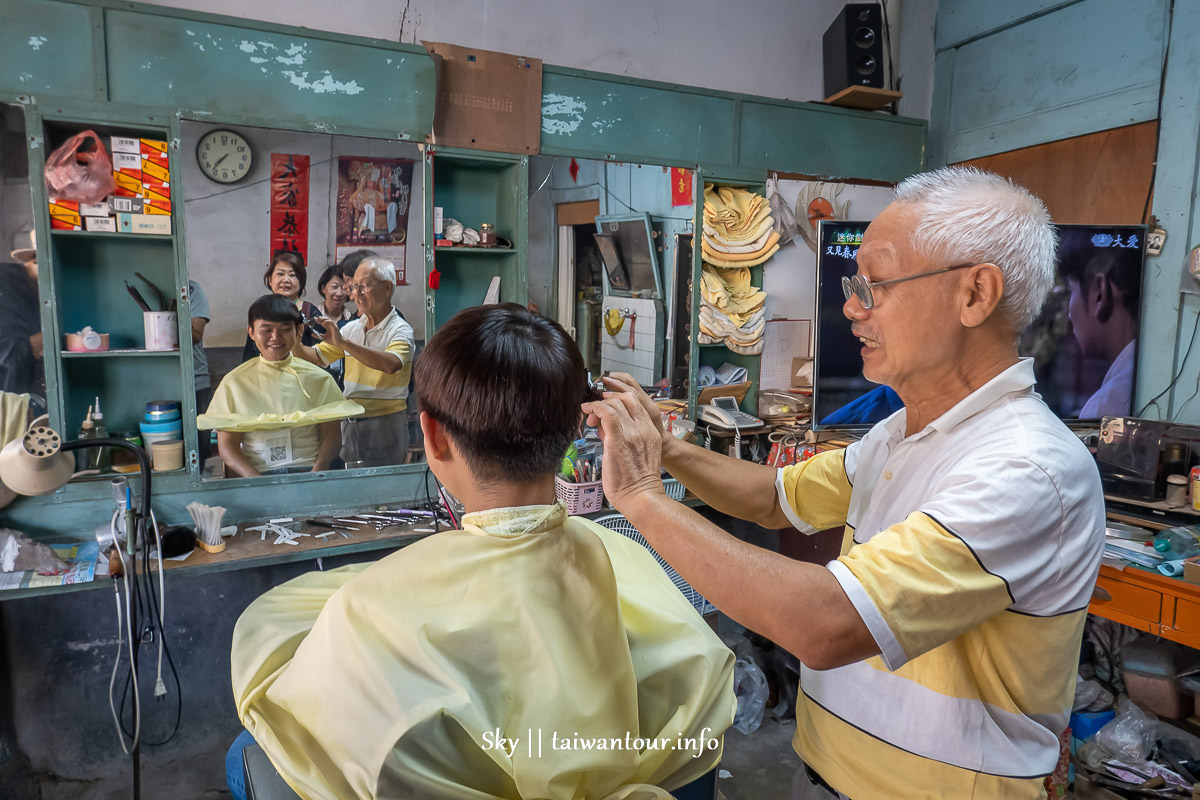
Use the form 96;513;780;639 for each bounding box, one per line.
196;355;362;432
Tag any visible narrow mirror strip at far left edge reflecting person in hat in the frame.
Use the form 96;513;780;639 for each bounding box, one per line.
0;106;46;410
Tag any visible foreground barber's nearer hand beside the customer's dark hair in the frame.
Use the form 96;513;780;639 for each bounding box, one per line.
583;392;666;511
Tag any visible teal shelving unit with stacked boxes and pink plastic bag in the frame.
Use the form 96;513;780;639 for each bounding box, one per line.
26;112;196;477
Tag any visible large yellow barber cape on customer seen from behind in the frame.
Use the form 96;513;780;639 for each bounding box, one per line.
225;504;736;800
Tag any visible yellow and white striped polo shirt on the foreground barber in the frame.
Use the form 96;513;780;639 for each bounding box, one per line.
776;359;1104;800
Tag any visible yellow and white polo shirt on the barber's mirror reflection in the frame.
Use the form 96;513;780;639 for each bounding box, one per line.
313;308;413;417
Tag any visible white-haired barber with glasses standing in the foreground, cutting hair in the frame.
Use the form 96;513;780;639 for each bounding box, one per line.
583;168;1104;799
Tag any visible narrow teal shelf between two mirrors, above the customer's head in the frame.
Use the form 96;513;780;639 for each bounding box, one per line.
424;148;529;338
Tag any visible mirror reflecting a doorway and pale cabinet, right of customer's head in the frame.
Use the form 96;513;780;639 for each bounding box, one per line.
529;156;694;397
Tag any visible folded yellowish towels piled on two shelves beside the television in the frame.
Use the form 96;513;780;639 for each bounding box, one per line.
700;184;779;355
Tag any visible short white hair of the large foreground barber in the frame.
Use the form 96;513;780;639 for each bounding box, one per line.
895;167;1058;333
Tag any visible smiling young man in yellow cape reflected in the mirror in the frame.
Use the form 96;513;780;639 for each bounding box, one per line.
196;294;362;477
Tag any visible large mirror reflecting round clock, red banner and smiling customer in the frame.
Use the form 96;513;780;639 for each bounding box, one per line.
181;121;425;480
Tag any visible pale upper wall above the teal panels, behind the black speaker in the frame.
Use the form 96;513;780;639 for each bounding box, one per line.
131;0;937;119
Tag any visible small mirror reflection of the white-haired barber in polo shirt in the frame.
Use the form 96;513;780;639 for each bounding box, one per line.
293;257;413;467
